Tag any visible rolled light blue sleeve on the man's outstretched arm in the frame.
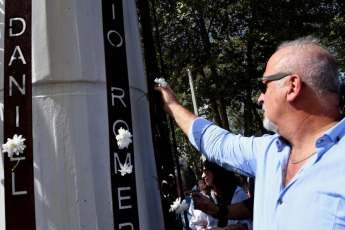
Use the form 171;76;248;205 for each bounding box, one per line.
188;118;272;177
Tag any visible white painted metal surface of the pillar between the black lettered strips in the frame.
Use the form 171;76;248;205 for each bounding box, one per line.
0;0;164;230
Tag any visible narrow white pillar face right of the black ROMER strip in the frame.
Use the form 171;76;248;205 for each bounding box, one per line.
123;0;164;230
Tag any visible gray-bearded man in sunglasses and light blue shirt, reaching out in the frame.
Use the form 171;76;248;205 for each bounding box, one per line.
155;37;345;230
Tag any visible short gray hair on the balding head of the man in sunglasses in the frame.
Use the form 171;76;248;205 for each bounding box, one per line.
275;36;340;95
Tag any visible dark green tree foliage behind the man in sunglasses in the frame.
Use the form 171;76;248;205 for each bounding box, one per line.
148;0;345;180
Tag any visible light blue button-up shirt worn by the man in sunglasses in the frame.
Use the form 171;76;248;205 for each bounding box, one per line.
188;118;345;230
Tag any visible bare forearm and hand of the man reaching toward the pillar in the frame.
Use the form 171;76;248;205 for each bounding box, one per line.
154;86;197;135
